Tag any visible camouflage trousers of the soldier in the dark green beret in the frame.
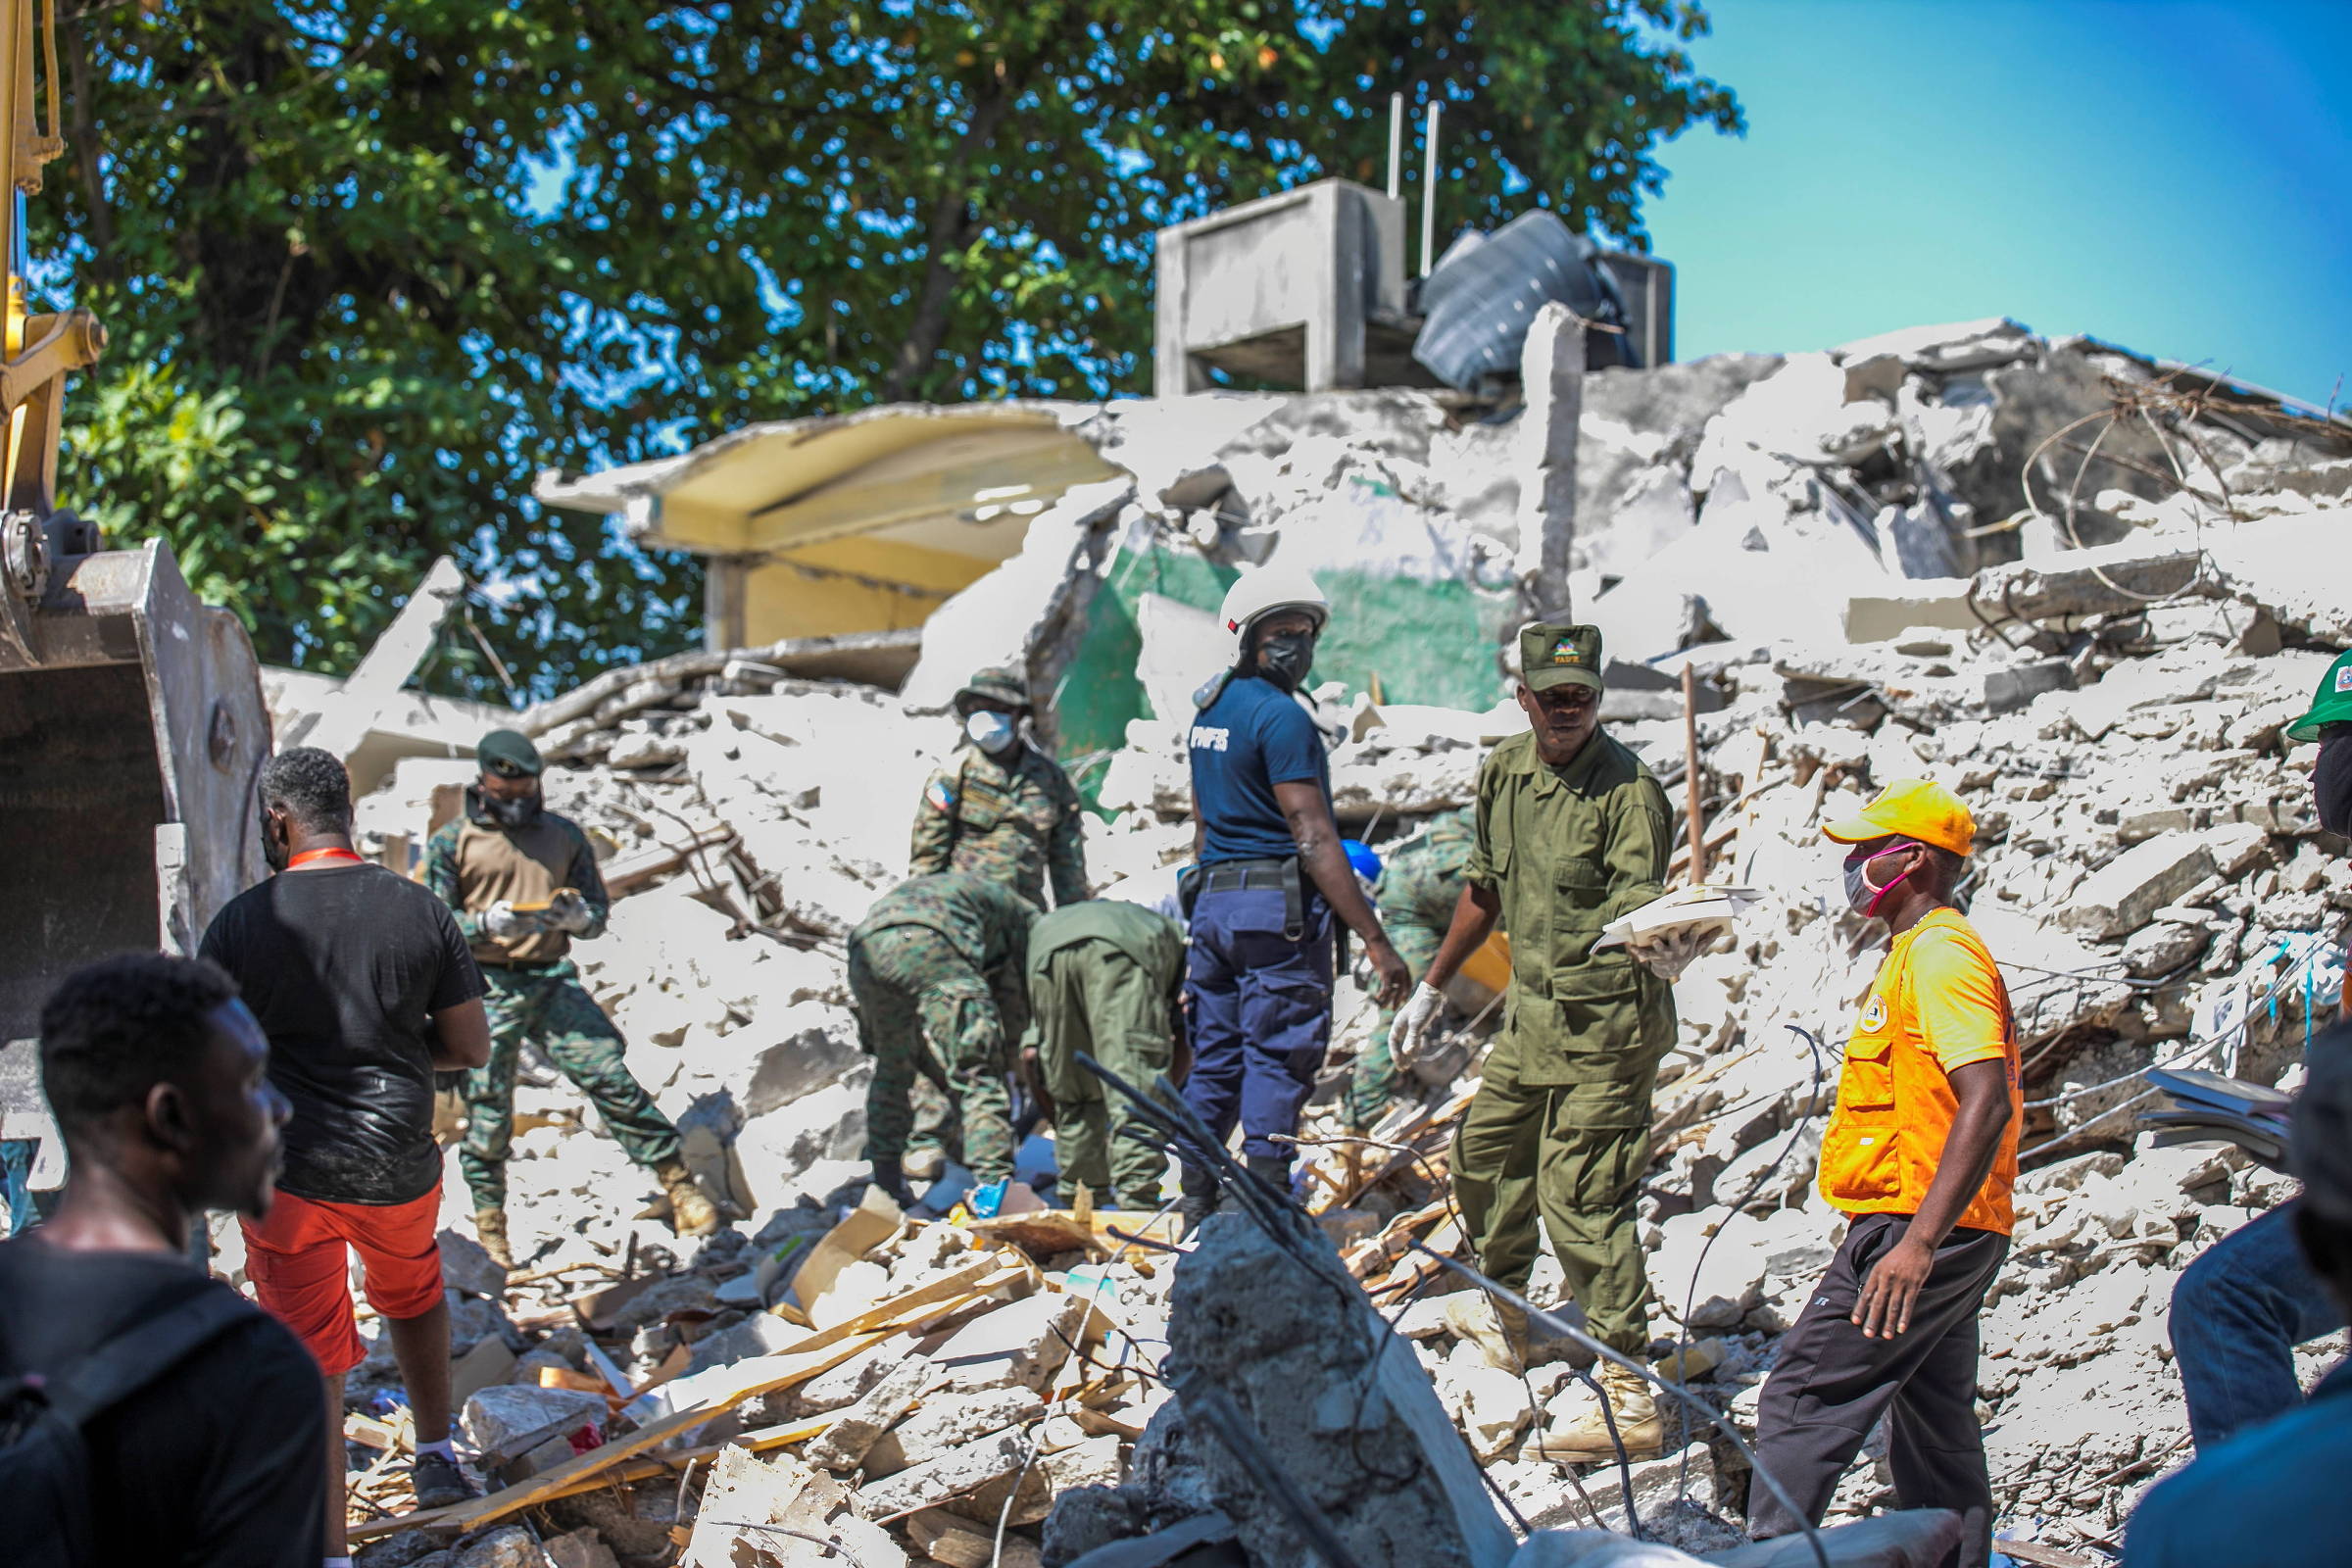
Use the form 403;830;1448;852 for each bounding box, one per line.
457;964;677;1208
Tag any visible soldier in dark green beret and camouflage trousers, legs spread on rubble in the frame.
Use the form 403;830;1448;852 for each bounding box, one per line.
425;729;719;1265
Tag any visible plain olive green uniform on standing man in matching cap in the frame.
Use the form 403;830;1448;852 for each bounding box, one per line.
1453;731;1675;1354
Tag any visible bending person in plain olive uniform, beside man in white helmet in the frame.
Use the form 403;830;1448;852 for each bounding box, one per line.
1028;898;1183;1208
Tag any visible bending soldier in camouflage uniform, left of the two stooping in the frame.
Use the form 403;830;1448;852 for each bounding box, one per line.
849;872;1037;1203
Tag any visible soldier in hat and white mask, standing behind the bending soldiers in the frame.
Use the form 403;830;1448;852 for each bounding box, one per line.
907;670;1087;909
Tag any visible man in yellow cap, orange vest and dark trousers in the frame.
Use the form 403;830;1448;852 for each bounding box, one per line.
1747;778;2025;1563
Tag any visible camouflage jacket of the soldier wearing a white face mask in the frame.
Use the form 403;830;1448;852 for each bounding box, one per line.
907;741;1087;909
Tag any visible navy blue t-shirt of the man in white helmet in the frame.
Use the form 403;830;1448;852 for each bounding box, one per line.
1193;674;1331;865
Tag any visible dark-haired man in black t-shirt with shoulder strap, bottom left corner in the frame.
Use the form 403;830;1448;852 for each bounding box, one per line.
0;955;327;1568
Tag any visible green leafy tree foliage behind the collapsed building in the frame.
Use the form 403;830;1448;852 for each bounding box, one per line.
33;0;1740;691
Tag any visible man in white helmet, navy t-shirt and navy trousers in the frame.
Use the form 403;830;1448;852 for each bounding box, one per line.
1183;569;1411;1225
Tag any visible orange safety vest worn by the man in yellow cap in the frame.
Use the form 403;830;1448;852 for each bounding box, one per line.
1821;909;2025;1237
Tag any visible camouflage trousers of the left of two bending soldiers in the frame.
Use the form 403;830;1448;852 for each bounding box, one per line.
849;926;1013;1183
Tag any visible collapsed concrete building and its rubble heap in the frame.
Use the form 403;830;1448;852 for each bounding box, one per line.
248;315;2352;1568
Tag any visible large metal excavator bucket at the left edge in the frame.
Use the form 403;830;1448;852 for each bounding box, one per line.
0;541;270;1042
